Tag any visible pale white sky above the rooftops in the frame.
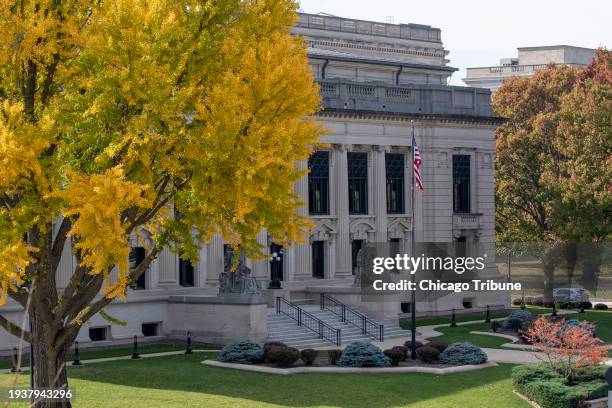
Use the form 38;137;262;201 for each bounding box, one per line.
299;0;612;85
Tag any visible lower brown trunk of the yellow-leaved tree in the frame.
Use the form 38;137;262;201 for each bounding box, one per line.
31;316;71;408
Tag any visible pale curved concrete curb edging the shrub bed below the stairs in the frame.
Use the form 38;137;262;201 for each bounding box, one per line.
201;360;497;375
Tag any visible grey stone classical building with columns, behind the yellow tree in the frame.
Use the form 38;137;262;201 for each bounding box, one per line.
0;14;508;349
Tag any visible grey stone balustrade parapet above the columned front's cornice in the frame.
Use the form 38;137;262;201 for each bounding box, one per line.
319;79;493;118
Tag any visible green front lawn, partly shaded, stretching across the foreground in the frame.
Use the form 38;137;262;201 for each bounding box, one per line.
0;353;528;408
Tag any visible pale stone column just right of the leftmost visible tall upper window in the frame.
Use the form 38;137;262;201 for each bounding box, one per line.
334;144;351;277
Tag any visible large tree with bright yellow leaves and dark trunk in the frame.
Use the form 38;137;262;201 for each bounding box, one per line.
0;0;321;406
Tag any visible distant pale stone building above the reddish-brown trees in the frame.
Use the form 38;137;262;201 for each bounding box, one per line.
463;45;595;91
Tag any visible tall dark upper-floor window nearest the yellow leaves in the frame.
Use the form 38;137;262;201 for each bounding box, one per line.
308;151;329;215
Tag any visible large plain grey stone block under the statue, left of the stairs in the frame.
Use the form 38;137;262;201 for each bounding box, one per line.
168;295;268;345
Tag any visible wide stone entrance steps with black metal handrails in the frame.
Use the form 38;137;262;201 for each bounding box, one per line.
267;299;410;349
